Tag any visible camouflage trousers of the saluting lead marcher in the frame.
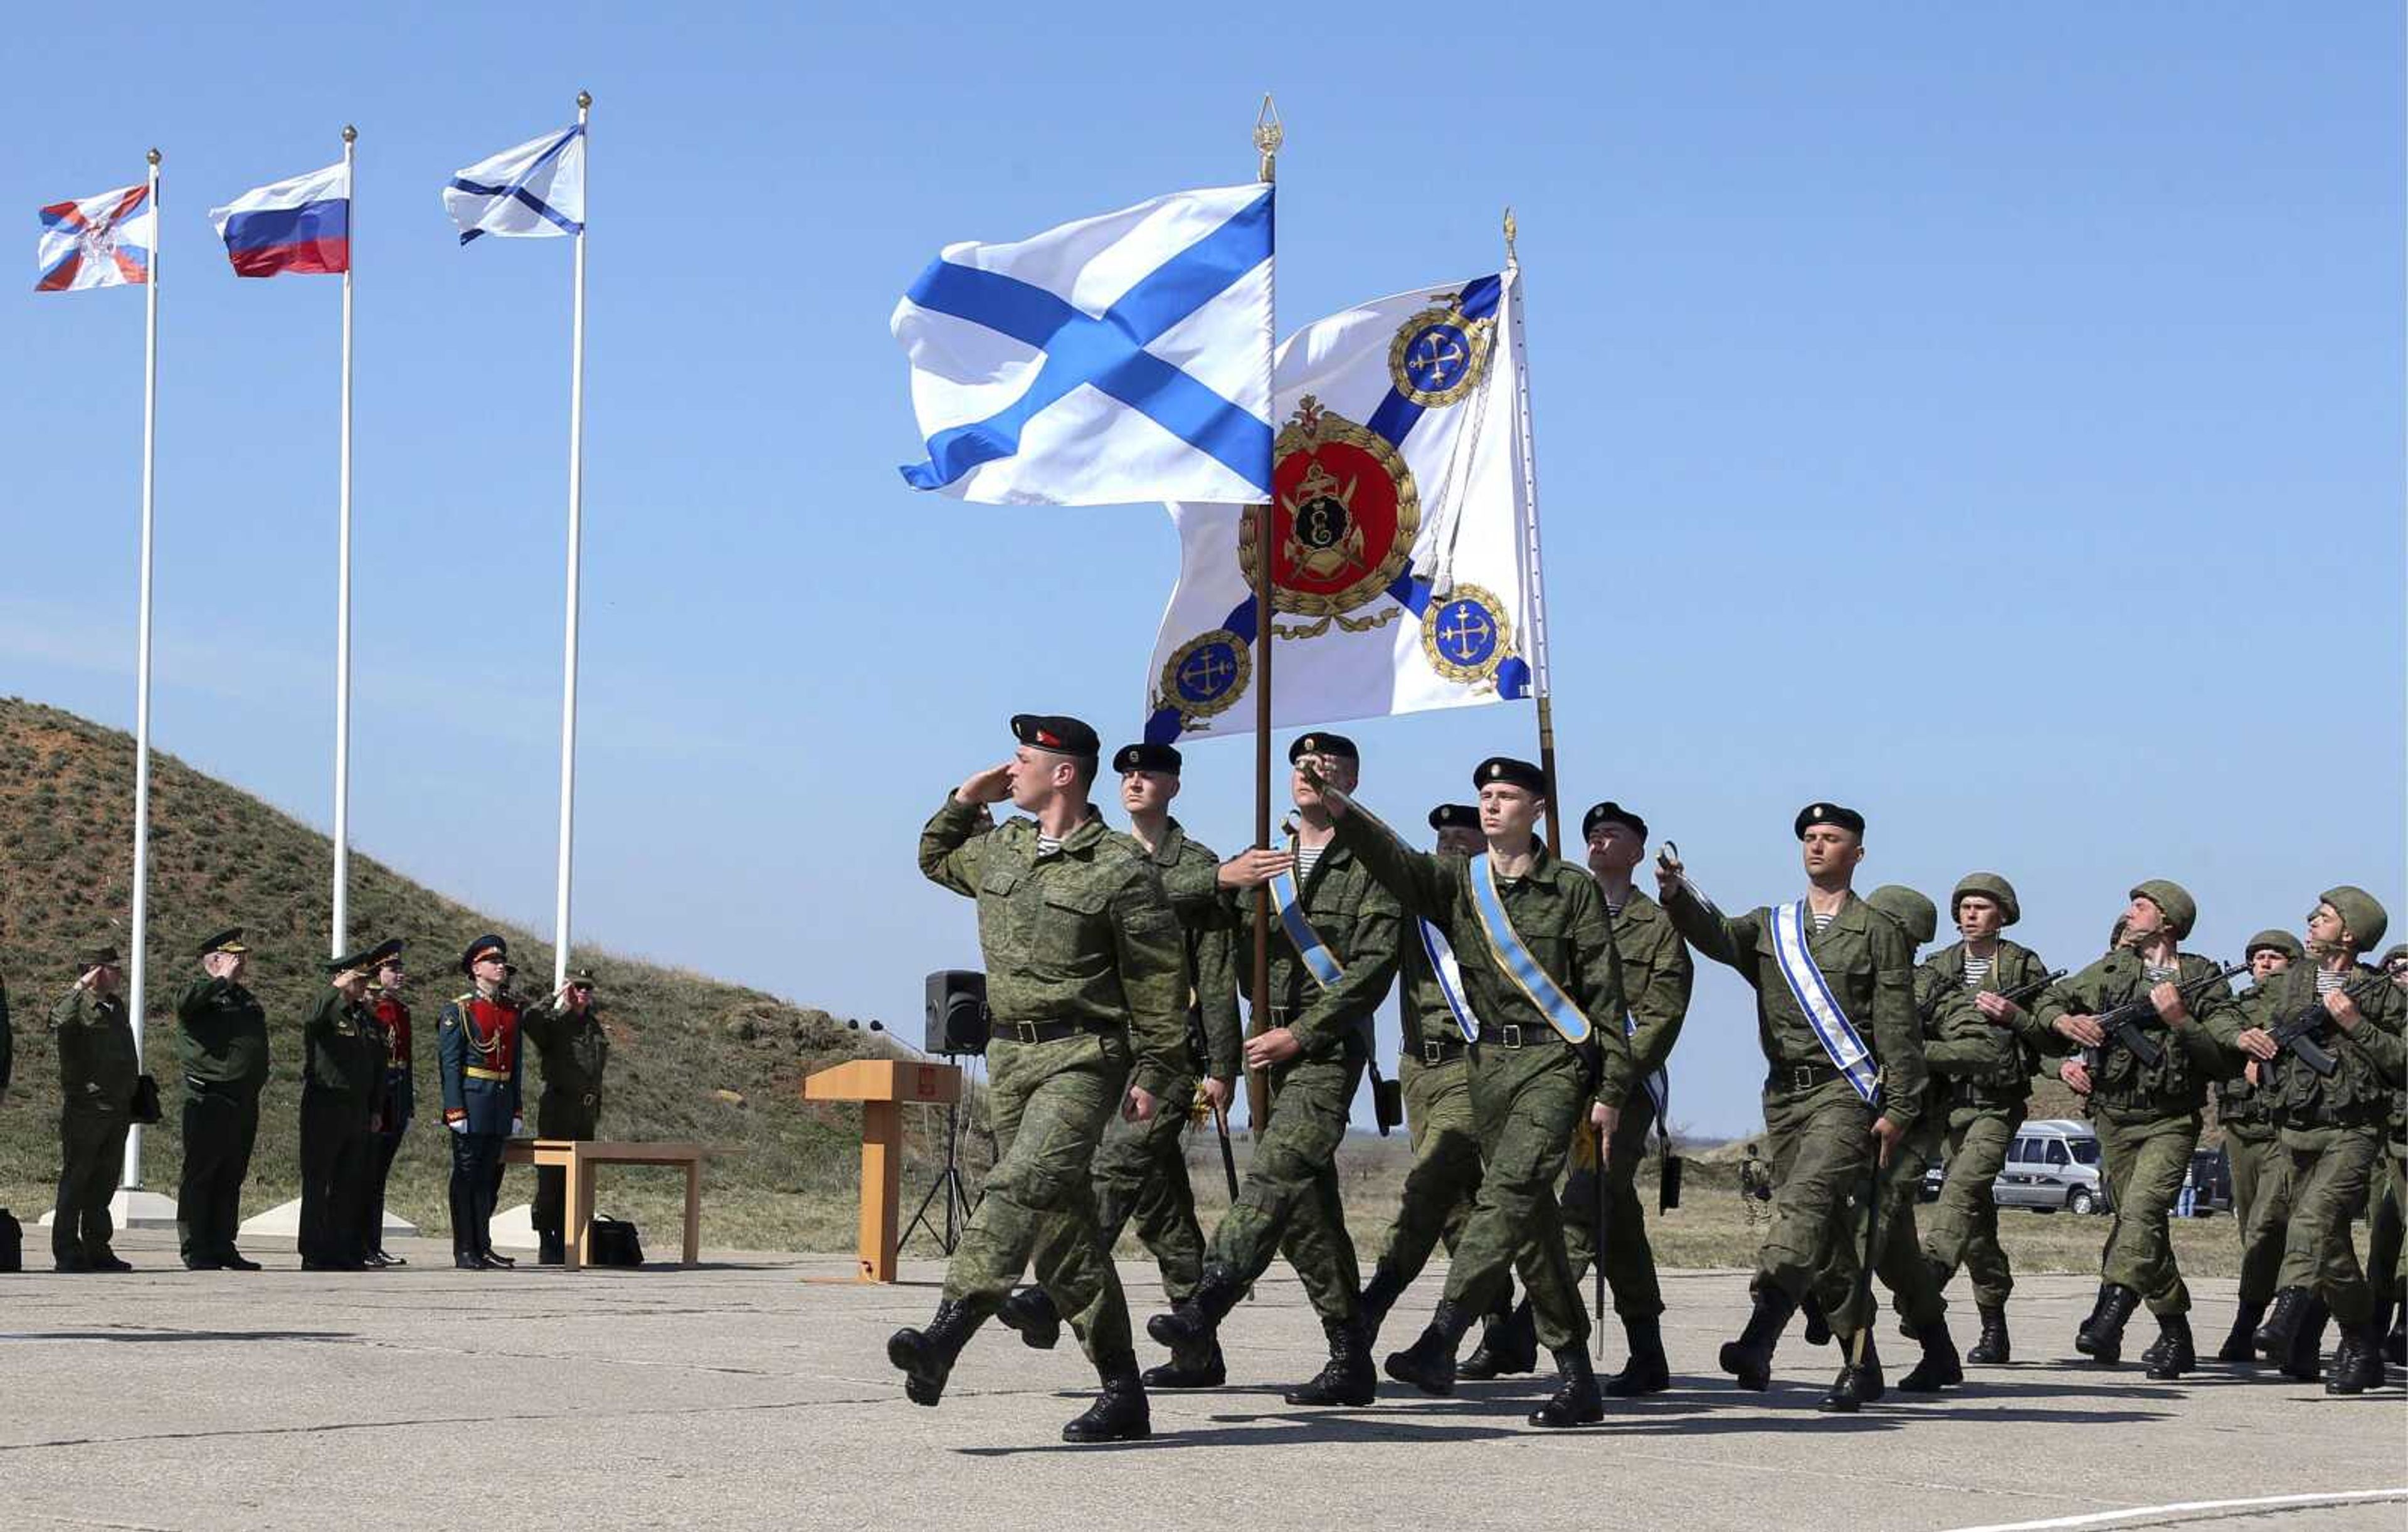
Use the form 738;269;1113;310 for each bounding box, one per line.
944;1033;1136;1366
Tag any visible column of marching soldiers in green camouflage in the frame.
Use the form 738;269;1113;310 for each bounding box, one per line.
886;716;2408;1440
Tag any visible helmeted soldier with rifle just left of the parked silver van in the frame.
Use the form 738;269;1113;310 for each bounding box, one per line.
1919;872;2049;1366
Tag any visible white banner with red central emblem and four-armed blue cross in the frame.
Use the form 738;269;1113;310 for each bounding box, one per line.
1146;272;1529;742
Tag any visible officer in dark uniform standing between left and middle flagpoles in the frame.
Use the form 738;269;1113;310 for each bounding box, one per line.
176;925;267;1272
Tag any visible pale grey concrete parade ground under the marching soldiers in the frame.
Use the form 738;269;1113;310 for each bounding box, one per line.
0;1231;2408;1532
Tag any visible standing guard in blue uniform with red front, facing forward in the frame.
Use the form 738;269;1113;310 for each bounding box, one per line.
436;934;527;1272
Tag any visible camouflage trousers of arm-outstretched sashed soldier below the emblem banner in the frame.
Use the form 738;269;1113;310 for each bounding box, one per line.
1447;1033;1589;1351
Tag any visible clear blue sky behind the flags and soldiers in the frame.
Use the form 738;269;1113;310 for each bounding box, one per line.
0;3;2408;1132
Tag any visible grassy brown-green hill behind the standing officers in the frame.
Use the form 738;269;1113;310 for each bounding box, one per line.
0;699;978;1262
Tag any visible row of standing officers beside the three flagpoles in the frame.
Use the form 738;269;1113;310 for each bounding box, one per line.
0;927;610;1272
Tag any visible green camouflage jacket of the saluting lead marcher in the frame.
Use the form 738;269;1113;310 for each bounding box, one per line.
920;795;1187;1096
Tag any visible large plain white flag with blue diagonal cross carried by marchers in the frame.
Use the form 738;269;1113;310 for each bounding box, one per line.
894;186;1272;506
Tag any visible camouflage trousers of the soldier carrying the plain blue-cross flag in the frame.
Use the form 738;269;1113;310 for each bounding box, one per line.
1207;1053;1363;1323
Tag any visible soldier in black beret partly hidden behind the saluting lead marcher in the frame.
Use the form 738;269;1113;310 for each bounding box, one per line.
997;744;1242;1388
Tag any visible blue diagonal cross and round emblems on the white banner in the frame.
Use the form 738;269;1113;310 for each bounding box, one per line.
1149;280;1514;732
